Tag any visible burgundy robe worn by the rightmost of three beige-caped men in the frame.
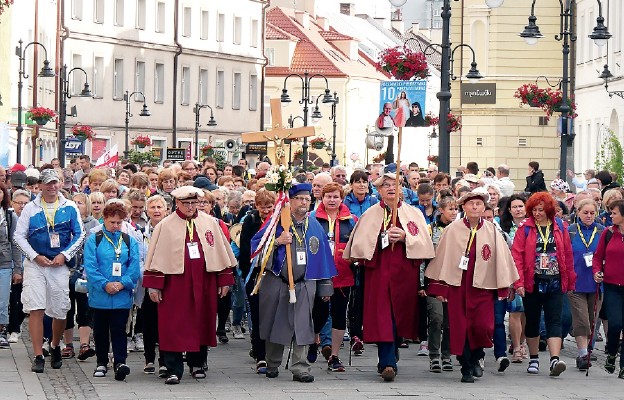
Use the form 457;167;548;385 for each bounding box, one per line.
427;221;509;356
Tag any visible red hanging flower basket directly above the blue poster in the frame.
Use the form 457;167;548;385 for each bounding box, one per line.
377;46;429;80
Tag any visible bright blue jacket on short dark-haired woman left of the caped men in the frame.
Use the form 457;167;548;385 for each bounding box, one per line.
84;228;141;310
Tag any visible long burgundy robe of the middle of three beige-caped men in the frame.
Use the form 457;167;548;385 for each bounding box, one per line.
363;218;421;343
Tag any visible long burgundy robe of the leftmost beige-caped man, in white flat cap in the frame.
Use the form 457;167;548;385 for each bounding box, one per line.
143;211;234;352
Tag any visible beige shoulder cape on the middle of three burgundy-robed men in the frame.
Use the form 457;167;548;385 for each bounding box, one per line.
342;203;435;260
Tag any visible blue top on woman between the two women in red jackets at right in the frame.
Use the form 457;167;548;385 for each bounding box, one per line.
568;222;605;293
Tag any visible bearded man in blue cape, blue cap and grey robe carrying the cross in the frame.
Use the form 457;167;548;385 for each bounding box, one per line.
251;183;337;382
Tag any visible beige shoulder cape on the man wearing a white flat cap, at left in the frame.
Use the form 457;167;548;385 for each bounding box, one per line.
145;212;236;275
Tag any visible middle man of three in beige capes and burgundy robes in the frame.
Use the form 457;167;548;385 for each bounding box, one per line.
343;172;434;381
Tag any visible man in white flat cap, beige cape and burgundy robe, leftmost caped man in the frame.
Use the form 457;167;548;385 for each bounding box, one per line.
143;186;236;385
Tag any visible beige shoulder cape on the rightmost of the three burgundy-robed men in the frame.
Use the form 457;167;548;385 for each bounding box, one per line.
425;219;520;289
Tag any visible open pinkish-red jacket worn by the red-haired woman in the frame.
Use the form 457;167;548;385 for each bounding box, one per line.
511;217;576;293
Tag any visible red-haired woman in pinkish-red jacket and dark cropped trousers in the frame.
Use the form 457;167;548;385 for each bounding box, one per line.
511;192;576;376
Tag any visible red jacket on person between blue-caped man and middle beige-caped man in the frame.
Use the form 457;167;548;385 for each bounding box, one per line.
310;203;357;289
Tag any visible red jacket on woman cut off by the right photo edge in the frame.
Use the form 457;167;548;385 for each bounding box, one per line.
592;225;624;286
